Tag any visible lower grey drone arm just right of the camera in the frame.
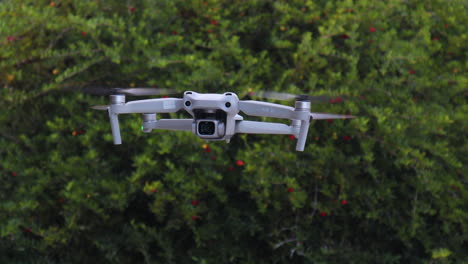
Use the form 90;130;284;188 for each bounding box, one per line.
236;121;297;135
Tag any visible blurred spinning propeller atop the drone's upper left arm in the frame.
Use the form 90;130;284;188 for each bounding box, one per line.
79;87;177;96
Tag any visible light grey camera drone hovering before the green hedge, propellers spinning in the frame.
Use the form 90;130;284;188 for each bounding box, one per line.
84;87;354;151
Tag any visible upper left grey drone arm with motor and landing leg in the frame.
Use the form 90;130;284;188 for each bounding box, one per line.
107;95;183;145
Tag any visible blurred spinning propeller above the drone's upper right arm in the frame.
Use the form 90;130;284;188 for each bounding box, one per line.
249;91;343;103
